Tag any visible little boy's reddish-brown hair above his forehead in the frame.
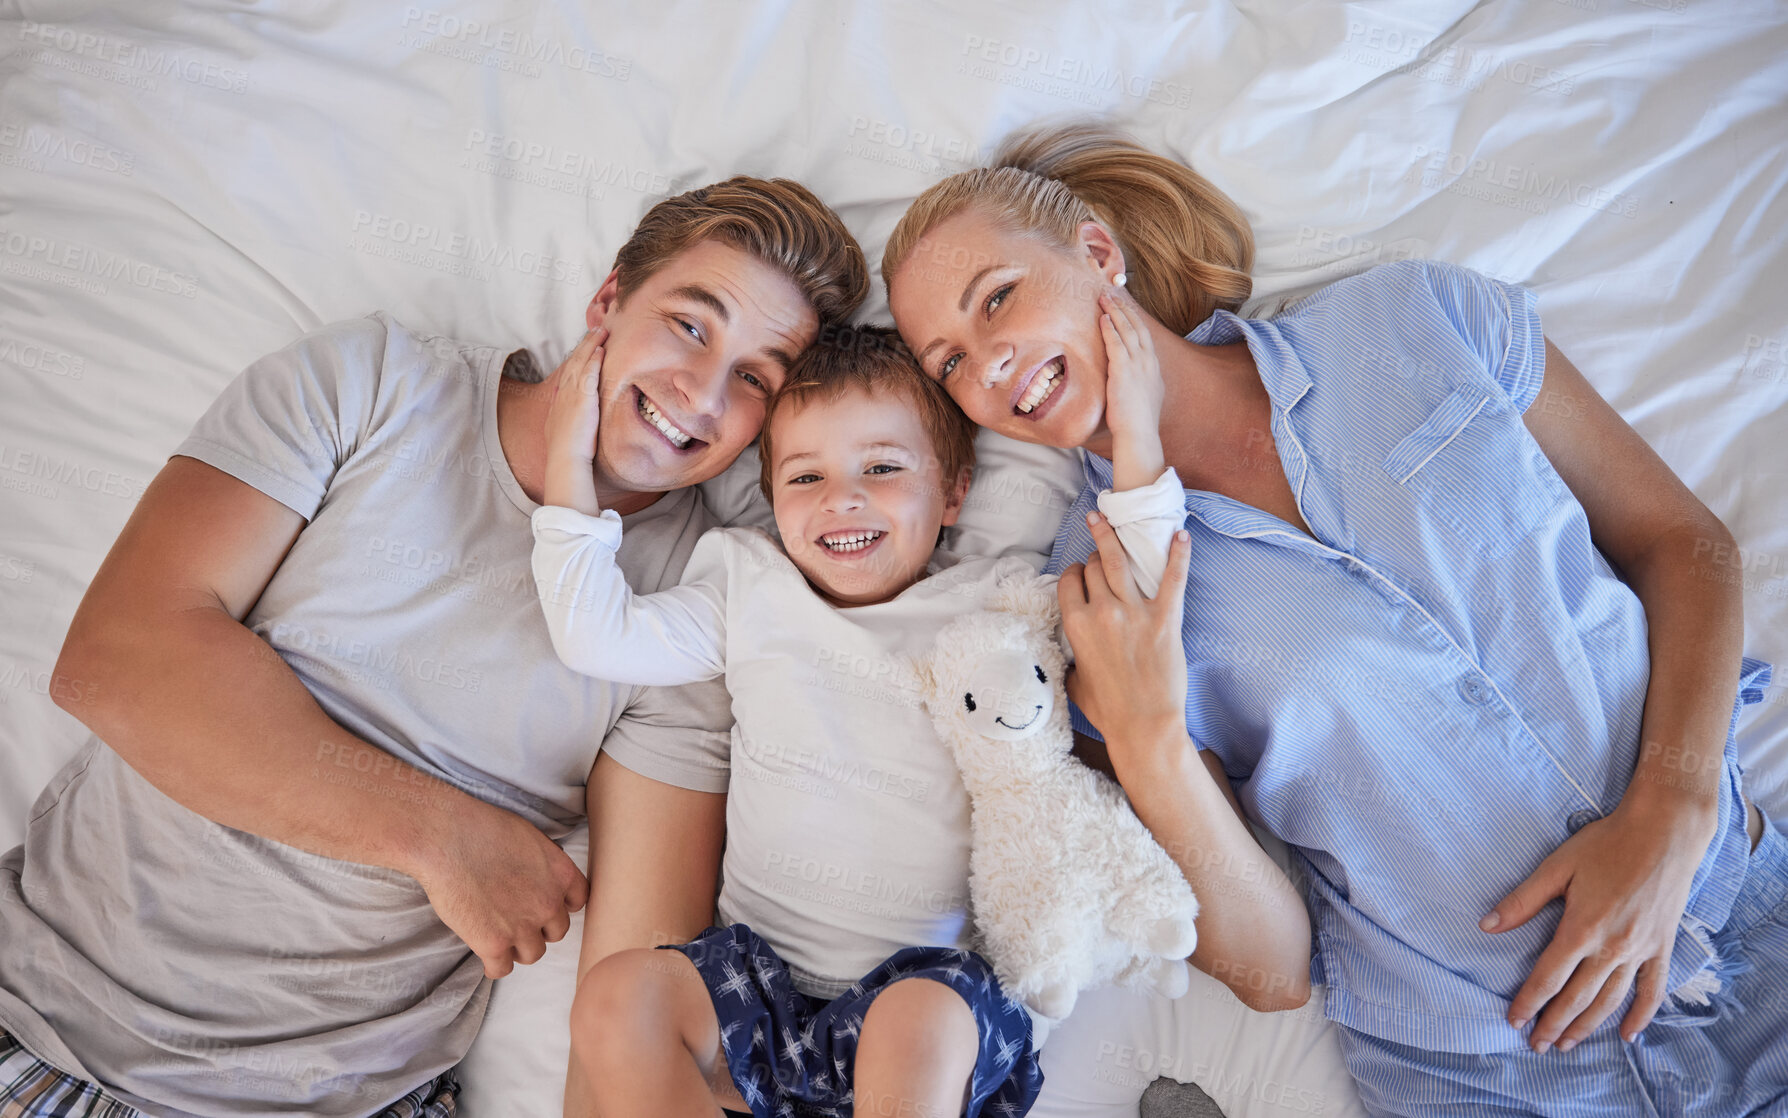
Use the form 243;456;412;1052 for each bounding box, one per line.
758;324;978;503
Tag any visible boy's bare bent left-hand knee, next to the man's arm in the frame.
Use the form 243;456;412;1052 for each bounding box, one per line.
570;948;749;1118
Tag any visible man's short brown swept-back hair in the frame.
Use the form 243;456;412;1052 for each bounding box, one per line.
615;175;869;326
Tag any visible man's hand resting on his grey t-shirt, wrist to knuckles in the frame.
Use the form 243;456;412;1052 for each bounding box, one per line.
415;803;590;978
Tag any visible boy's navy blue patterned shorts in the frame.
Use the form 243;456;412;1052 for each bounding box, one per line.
663;923;1042;1118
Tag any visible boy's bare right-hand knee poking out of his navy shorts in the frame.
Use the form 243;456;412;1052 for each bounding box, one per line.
853;978;980;1118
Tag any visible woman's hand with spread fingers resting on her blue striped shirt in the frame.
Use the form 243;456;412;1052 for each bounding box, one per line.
1479;807;1715;1052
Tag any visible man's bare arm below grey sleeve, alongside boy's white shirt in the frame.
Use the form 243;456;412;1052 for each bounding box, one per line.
565;751;726;1118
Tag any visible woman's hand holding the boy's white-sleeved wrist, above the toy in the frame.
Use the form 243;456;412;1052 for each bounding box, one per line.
1057;512;1193;783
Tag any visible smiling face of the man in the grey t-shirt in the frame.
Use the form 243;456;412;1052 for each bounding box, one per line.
586;240;819;492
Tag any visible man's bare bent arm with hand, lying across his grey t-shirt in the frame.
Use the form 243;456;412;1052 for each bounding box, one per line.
52;456;585;977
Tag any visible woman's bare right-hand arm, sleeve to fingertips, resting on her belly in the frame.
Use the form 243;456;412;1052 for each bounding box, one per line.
1484;340;1745;1050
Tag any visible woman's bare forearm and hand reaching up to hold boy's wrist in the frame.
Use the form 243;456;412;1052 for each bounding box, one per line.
1058;513;1311;1011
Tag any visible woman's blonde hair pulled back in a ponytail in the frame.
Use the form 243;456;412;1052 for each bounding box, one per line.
881;123;1253;335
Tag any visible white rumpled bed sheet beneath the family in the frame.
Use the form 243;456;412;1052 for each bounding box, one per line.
0;0;1788;1114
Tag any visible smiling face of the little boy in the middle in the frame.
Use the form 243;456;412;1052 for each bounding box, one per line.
771;388;969;606
